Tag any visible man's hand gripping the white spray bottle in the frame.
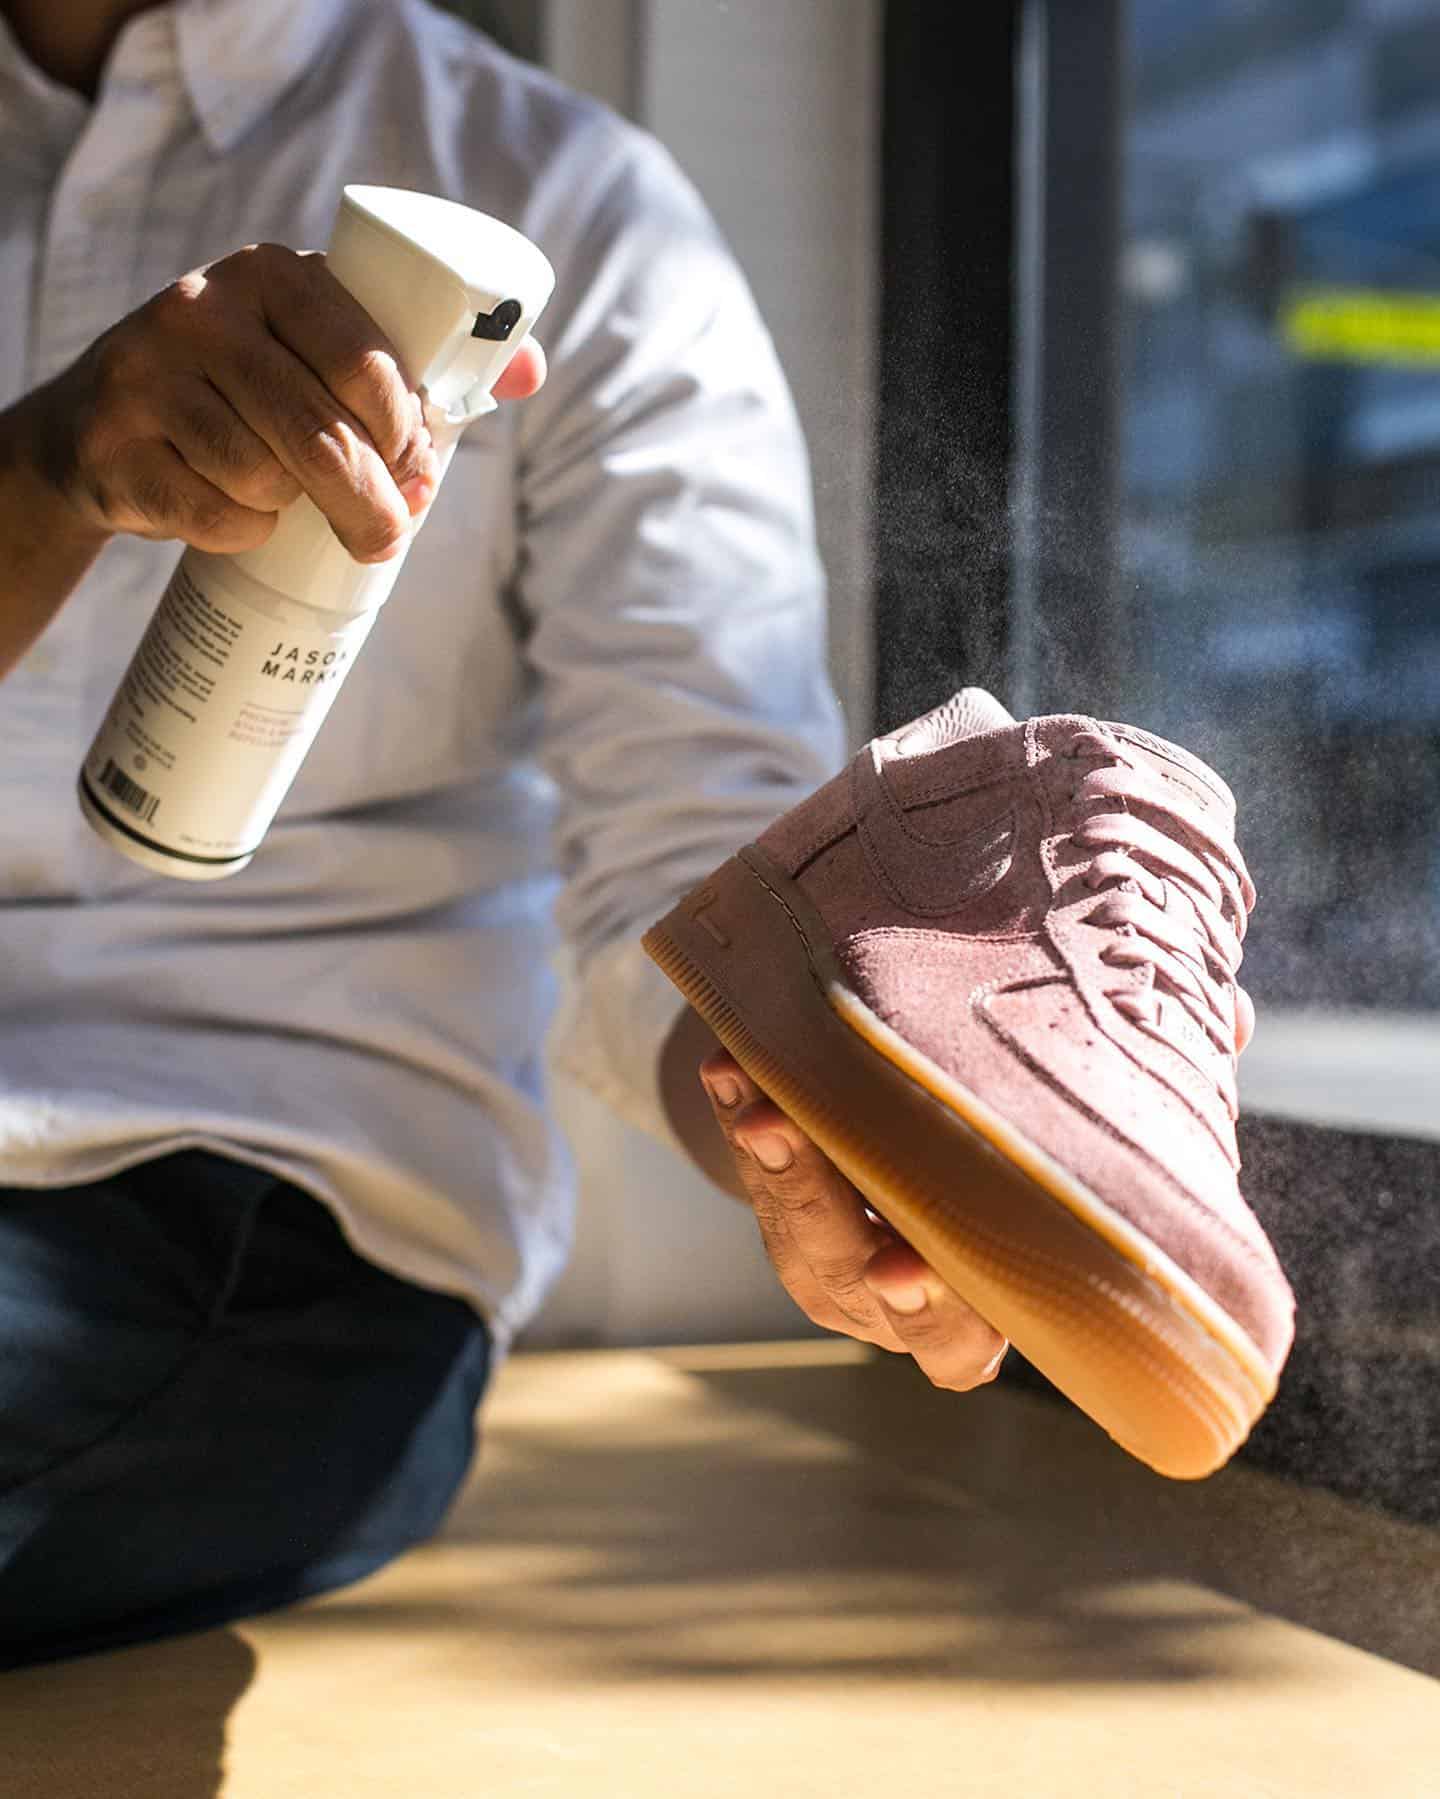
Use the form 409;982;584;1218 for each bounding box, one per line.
22;243;544;563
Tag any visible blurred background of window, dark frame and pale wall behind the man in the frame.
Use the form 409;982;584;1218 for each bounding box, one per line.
444;0;1440;1518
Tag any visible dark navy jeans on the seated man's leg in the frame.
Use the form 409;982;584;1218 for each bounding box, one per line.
0;1151;490;1668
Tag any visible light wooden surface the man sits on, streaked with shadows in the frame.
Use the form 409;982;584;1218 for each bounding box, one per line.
0;1344;1440;1799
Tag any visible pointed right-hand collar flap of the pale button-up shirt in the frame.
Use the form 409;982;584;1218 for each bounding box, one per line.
175;0;360;151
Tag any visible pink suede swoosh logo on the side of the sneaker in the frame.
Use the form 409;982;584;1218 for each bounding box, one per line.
850;748;1015;917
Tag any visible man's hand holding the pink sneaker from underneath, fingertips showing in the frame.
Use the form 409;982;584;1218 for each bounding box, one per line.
700;1051;1006;1391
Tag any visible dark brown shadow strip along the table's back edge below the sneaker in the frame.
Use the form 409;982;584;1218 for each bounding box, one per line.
673;1349;1440;1677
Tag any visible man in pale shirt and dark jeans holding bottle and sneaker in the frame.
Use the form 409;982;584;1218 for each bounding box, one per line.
0;0;1003;1662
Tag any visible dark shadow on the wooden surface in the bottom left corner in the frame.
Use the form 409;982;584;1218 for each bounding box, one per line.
0;1630;256;1799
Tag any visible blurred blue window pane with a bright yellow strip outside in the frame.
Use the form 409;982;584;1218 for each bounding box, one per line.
1120;0;1440;1009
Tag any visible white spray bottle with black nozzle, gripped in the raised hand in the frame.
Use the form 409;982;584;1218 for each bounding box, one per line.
79;187;554;882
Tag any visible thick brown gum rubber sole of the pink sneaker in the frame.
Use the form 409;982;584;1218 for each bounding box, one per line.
644;847;1274;1479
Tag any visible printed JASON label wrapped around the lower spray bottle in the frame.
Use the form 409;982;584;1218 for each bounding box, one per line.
85;558;376;862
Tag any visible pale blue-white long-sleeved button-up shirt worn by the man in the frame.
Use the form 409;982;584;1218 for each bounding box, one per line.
0;0;841;1342
